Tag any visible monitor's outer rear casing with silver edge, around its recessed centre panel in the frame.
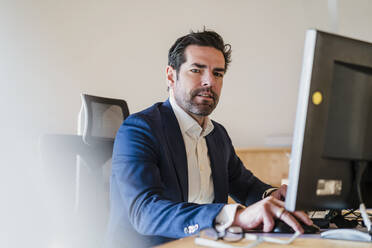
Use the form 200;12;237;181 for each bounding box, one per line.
285;30;372;211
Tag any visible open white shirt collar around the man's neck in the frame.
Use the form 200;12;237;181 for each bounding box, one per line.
169;89;214;138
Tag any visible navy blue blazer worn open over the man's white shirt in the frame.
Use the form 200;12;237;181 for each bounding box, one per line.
106;100;271;247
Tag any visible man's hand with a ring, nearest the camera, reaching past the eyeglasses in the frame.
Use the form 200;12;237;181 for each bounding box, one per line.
232;196;313;233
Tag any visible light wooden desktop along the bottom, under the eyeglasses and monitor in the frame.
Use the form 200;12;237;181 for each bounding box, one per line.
158;235;372;248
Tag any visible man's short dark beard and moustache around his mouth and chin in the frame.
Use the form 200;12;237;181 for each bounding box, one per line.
176;88;219;116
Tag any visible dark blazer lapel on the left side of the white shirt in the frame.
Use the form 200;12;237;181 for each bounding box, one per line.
161;100;189;201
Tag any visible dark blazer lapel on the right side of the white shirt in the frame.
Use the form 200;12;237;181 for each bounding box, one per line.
206;130;228;203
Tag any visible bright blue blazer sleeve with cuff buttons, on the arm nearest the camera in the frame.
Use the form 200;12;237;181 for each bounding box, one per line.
112;115;224;238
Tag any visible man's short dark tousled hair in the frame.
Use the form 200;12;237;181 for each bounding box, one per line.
168;28;231;75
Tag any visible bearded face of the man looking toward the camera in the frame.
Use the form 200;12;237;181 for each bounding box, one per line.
167;45;225;120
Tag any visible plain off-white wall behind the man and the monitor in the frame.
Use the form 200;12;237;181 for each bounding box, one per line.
0;0;372;247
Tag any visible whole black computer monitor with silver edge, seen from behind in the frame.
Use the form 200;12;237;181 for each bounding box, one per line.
285;30;372;211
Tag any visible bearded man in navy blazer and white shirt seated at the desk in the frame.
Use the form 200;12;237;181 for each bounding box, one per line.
107;31;311;247
